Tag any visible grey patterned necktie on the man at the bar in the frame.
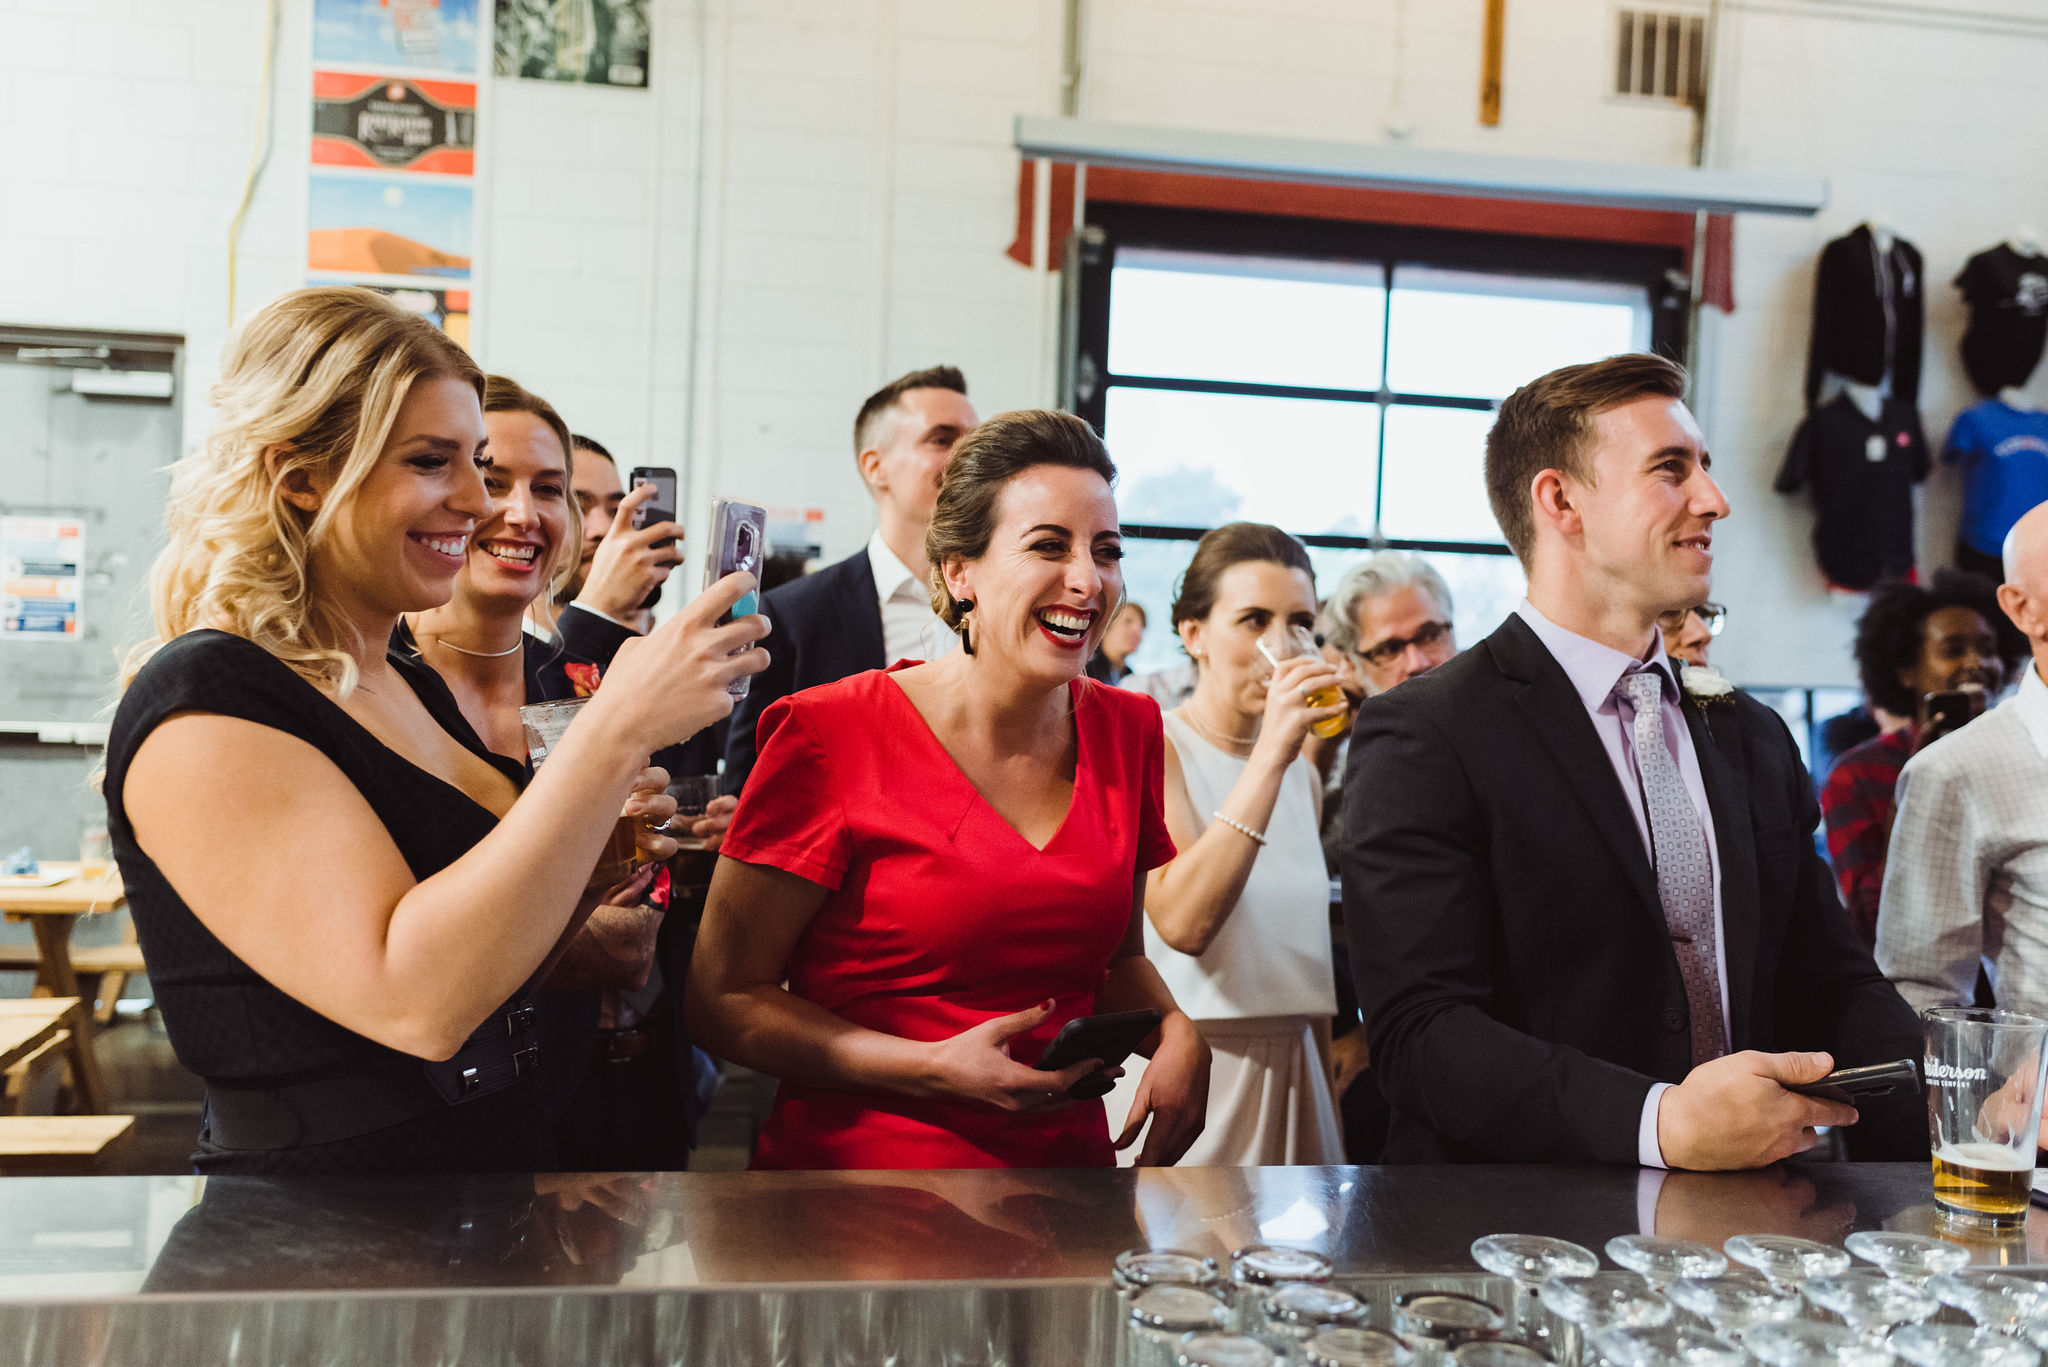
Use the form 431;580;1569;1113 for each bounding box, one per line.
1614;668;1729;1068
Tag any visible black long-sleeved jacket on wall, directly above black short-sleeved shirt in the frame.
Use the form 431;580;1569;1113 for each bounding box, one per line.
1806;223;1925;408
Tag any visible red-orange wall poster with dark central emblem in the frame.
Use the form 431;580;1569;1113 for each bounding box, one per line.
313;72;477;176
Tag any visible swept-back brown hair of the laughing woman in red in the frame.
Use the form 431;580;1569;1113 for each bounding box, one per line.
924;408;1116;647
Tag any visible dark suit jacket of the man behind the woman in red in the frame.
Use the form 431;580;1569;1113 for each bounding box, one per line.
725;547;889;793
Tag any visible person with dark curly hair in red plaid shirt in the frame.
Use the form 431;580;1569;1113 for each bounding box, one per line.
1821;570;2025;945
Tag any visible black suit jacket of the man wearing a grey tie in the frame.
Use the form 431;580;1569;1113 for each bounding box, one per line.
1341;617;1927;1164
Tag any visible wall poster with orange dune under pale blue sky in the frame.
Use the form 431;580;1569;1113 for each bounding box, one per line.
305;170;475;289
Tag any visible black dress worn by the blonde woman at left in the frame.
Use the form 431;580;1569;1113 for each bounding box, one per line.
106;631;555;1172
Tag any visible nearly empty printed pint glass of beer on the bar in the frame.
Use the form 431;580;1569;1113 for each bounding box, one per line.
1921;1006;2048;1224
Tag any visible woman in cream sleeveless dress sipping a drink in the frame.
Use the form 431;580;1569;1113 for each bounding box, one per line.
1106;523;1343;1166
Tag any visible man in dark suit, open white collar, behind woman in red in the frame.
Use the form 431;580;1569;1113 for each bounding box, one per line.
725;365;981;793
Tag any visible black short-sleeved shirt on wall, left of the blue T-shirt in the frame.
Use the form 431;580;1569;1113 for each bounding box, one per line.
1778;396;1927;590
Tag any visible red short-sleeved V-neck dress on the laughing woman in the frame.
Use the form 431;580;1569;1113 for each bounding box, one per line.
723;660;1174;1168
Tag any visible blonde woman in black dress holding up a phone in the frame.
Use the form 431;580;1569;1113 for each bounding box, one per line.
104;289;766;1172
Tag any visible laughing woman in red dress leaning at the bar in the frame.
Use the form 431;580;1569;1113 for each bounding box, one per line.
688;412;1208;1168
